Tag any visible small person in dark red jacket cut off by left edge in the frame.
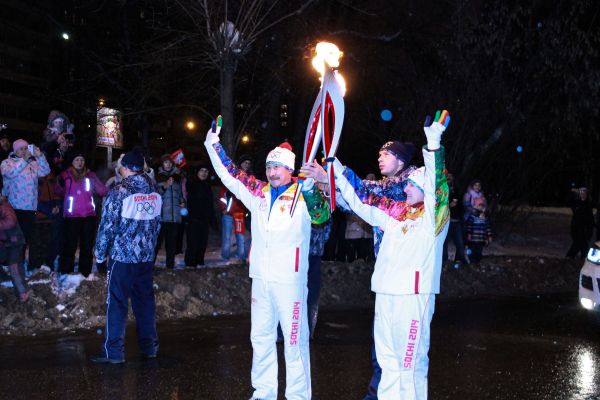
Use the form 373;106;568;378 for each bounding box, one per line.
0;198;31;303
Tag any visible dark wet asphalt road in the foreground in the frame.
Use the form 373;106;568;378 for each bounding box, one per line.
0;295;600;400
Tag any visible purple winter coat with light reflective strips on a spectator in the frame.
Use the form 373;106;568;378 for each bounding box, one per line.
55;168;108;218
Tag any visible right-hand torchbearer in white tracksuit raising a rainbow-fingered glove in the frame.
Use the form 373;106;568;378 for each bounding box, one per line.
335;114;449;400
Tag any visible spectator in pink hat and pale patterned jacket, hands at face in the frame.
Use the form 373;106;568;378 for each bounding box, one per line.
0;139;50;268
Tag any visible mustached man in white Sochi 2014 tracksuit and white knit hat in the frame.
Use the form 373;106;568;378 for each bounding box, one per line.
204;123;329;400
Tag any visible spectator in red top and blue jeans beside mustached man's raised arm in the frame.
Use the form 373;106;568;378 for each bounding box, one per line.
218;187;248;262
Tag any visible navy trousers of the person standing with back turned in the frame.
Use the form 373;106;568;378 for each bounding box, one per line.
101;260;158;359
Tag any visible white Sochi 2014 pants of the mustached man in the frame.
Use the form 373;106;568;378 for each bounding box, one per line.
250;279;311;400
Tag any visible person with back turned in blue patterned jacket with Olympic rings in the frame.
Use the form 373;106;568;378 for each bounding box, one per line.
91;151;162;364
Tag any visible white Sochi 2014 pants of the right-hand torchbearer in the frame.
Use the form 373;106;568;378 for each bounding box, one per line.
375;293;435;400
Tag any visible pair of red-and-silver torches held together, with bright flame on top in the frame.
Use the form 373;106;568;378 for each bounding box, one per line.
290;42;346;214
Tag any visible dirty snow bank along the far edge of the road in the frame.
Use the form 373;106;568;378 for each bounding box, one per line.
0;256;581;335
